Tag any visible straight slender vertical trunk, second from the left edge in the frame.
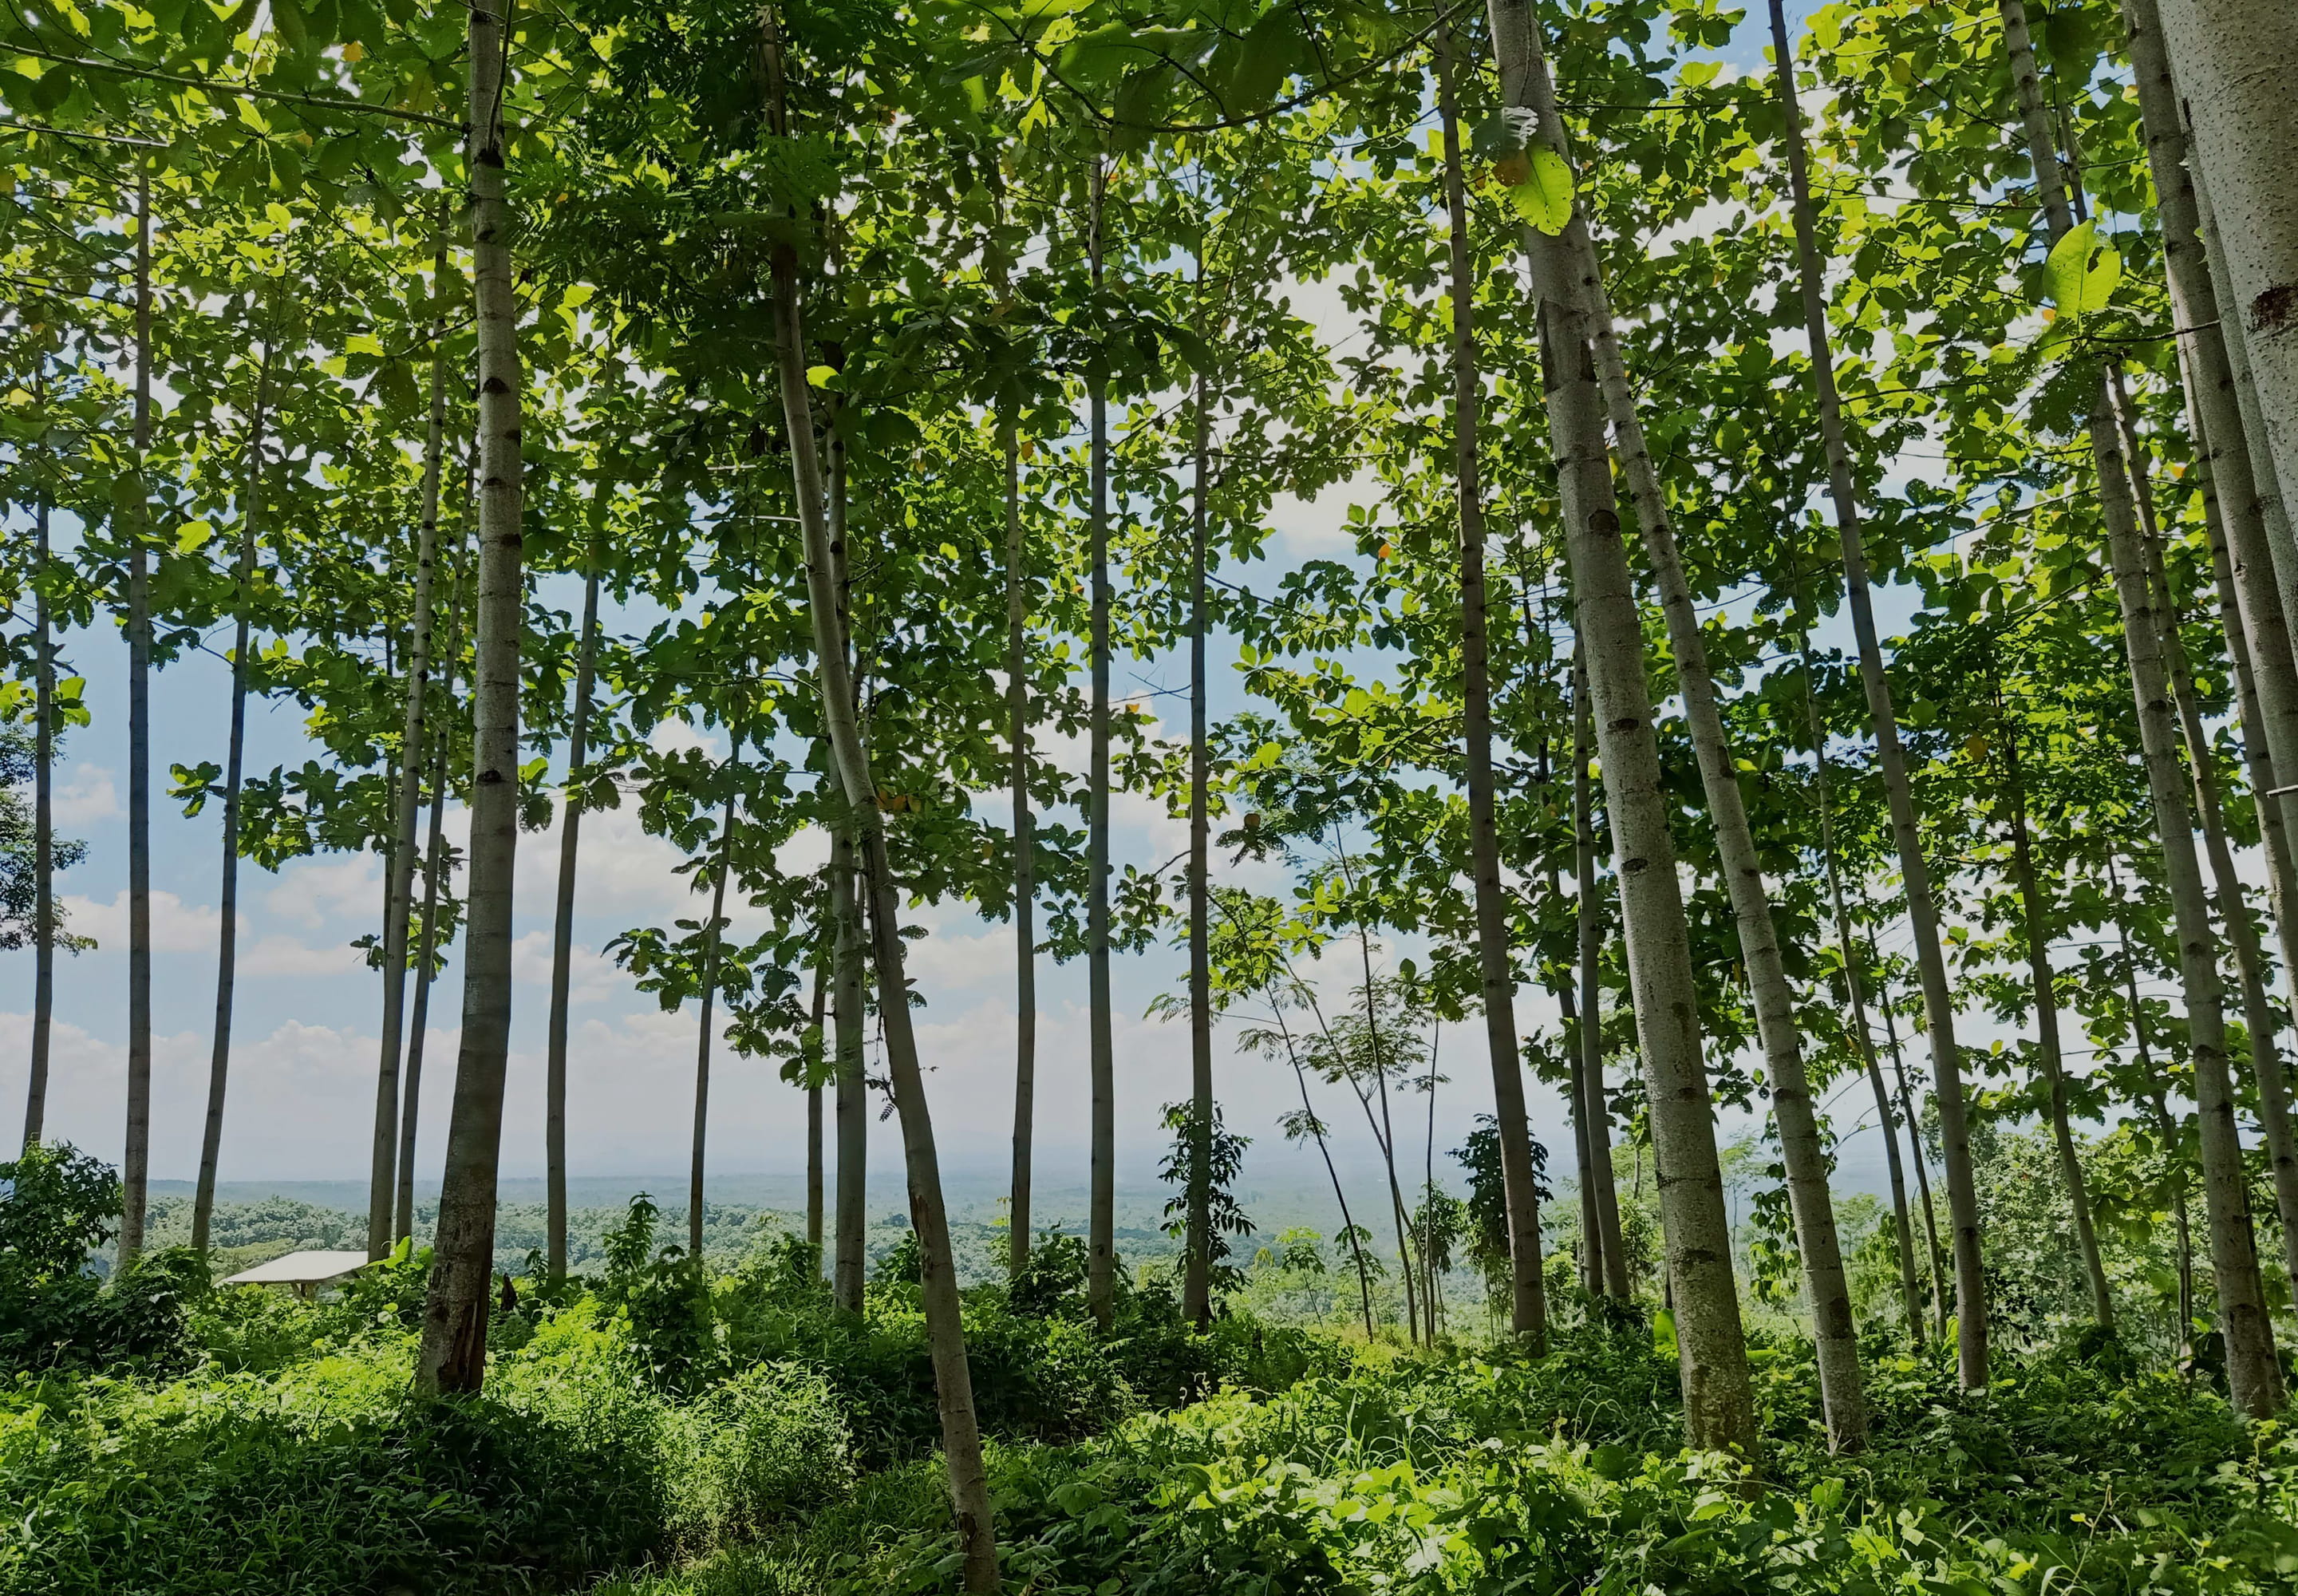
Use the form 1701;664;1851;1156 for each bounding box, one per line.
120;164;152;1270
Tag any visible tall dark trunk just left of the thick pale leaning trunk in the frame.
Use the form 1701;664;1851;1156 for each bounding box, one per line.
1436;23;1549;1350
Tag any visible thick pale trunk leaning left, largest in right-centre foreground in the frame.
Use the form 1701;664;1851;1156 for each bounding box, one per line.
1491;0;1755;1451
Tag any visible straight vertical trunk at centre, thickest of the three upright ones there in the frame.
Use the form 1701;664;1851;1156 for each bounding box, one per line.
1084;152;1117;1329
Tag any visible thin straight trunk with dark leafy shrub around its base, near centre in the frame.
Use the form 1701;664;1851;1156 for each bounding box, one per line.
1181;345;1214;1327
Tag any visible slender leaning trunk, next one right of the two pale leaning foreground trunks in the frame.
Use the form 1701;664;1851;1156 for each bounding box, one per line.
1771;0;1988;1392
